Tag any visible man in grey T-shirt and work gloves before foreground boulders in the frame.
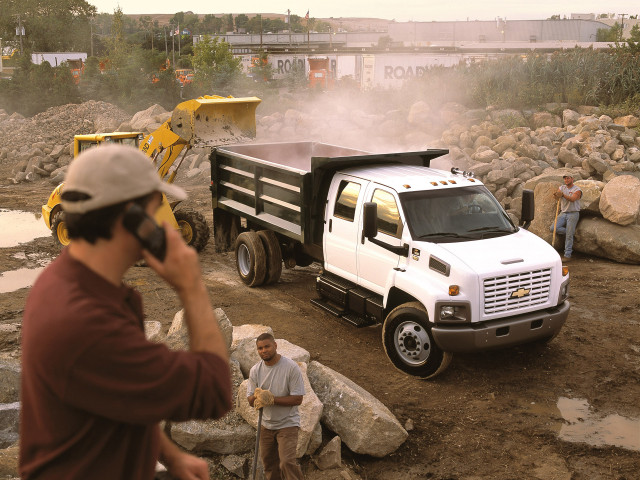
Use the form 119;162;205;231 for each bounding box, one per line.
247;333;304;480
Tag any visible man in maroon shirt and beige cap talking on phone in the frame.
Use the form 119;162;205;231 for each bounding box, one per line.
20;145;232;479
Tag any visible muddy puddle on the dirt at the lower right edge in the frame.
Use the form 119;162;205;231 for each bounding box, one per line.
527;397;640;451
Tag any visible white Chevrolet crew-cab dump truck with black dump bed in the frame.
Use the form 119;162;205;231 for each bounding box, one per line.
211;142;569;378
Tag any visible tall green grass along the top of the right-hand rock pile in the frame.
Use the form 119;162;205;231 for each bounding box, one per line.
415;48;640;108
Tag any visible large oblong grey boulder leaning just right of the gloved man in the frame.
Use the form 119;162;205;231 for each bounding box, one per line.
307;361;409;457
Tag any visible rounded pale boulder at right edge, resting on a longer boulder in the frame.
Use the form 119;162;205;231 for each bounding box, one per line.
600;175;640;225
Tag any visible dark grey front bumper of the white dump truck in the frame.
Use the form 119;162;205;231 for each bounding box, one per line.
431;301;570;353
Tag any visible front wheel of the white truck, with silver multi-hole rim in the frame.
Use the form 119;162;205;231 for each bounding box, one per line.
382;302;452;378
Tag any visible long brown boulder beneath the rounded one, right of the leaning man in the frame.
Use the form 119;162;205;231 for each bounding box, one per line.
573;218;640;265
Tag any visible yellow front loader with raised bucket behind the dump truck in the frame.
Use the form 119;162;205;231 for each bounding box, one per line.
42;95;260;251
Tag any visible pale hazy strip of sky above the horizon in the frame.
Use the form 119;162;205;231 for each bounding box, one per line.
87;0;640;22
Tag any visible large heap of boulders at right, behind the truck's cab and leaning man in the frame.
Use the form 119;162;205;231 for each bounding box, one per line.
441;107;640;263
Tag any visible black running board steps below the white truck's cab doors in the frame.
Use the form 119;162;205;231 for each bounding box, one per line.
311;273;384;327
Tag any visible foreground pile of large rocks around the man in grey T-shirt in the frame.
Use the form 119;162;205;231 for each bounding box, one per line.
158;309;408;476
